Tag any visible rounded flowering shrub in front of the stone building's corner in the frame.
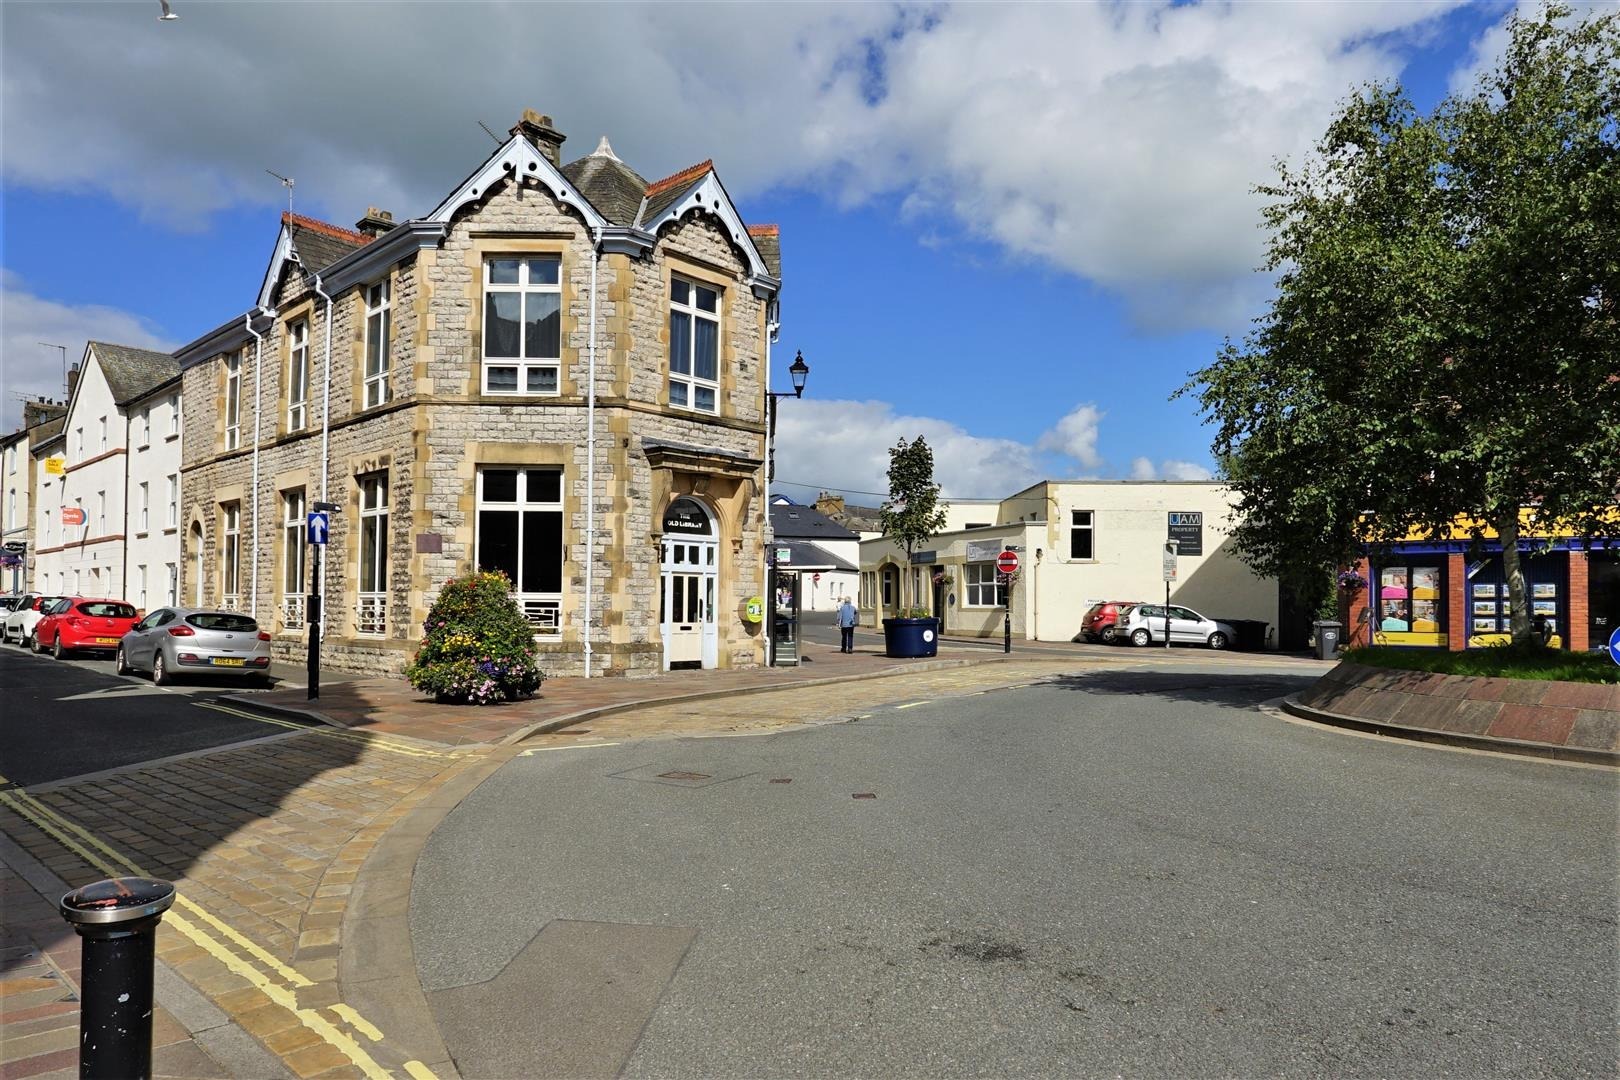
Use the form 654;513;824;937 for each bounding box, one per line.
405;573;544;704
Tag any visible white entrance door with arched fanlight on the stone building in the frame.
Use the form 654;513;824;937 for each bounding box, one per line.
658;499;719;670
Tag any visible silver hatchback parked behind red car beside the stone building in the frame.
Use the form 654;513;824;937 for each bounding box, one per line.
117;607;271;687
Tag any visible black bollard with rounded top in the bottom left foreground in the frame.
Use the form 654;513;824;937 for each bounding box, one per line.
60;878;175;1080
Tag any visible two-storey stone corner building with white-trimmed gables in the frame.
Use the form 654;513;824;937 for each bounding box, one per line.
177;112;779;674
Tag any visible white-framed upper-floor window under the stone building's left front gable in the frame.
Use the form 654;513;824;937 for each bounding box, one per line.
483;256;562;395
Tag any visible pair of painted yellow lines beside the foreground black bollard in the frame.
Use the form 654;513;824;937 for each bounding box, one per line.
0;786;434;1080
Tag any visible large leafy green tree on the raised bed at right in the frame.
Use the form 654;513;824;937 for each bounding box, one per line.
1178;5;1620;641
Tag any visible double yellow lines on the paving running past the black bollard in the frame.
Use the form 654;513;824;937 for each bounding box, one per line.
0;792;411;1080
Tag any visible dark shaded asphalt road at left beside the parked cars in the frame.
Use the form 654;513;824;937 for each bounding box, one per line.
0;634;319;787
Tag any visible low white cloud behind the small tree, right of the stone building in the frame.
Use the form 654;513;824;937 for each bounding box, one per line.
776;398;1042;505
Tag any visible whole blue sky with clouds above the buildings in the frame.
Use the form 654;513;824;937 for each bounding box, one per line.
0;0;1511;505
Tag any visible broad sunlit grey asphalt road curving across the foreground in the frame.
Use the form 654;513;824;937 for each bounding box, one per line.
410;669;1620;1078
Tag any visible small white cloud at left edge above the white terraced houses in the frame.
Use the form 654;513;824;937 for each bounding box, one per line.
0;270;173;431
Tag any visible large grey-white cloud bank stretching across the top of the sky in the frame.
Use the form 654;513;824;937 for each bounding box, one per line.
0;0;1470;329
